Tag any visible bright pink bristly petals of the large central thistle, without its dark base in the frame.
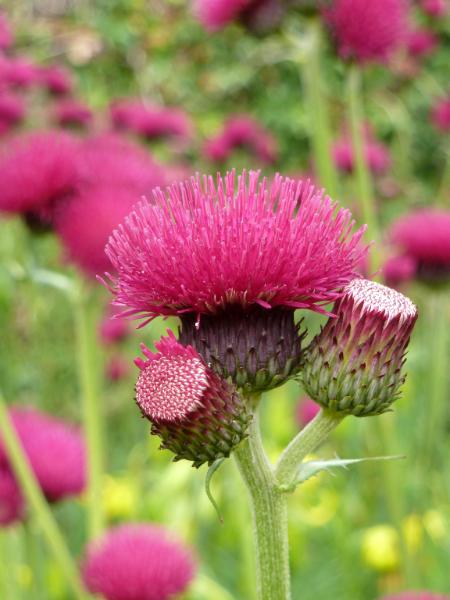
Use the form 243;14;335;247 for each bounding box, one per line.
106;171;366;319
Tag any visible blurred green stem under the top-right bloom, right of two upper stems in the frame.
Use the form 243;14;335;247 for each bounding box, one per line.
347;64;379;255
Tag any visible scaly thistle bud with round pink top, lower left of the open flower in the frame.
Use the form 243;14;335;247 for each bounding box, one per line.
135;331;251;467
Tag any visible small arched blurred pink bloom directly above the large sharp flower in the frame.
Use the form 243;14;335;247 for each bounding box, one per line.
204;115;277;163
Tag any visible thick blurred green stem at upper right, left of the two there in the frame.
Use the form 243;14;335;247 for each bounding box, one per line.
303;20;338;198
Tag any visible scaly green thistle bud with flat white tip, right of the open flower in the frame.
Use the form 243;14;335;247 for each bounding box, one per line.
301;279;417;417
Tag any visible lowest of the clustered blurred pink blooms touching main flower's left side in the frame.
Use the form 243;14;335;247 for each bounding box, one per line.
55;185;145;277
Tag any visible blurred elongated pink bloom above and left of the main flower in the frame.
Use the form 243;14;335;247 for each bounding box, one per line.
111;99;192;139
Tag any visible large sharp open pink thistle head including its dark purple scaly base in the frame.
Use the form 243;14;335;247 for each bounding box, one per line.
106;172;367;389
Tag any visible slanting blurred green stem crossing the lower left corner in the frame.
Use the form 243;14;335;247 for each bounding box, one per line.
0;393;87;600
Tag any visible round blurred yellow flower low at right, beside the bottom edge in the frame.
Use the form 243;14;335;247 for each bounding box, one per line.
361;525;400;571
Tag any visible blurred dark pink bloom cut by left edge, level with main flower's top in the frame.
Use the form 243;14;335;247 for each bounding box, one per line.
0;131;79;223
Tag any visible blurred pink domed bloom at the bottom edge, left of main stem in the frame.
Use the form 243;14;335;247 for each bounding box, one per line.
82;524;196;600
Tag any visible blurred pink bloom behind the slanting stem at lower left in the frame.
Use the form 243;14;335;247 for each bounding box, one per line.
0;407;86;502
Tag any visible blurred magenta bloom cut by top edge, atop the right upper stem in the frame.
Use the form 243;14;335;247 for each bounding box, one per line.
325;0;408;63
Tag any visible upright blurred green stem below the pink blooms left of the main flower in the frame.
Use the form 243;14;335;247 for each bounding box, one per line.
74;283;104;539
